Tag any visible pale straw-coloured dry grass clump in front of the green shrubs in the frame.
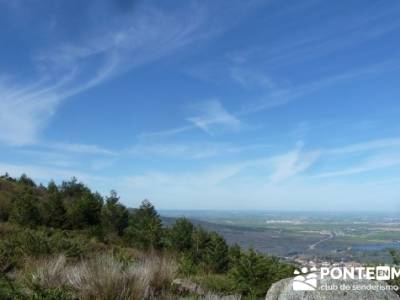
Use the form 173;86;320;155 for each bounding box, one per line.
30;254;177;300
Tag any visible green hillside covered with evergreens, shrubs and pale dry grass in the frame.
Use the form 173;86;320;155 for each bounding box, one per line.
0;174;293;299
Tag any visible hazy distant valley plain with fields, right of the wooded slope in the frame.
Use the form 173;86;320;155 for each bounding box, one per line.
161;211;400;263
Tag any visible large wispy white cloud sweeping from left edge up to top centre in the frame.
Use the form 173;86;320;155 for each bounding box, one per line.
0;2;256;145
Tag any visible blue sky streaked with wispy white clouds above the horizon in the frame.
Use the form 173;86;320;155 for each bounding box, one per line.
0;0;400;211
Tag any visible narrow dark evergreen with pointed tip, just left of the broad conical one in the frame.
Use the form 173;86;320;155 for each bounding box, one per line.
101;190;129;236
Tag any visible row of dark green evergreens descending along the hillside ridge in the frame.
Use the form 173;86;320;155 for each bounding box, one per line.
0;174;293;295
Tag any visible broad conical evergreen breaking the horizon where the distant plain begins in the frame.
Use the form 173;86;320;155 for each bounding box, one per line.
125;200;162;249
